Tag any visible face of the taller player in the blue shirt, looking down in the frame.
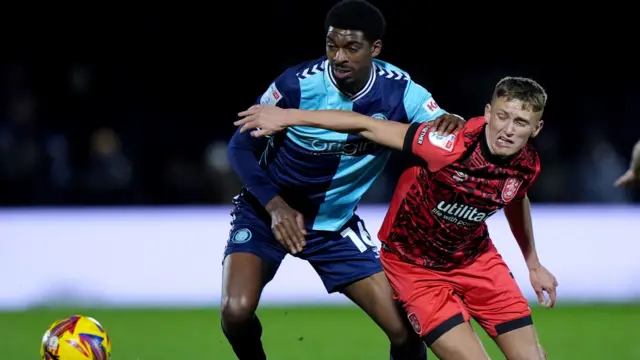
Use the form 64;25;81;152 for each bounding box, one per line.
326;27;382;85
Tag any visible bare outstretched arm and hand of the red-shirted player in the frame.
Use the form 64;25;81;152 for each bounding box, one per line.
234;105;409;150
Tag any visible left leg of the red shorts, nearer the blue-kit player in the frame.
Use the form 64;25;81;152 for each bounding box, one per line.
381;251;470;347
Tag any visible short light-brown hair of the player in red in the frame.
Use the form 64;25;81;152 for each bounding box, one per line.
493;76;547;112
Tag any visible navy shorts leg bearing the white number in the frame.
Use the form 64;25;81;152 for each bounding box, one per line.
298;216;382;293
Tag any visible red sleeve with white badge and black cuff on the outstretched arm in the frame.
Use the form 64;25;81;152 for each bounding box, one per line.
403;123;465;171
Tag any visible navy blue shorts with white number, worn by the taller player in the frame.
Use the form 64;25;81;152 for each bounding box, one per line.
224;195;382;293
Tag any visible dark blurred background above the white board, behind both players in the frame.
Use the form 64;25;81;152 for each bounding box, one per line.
0;1;640;206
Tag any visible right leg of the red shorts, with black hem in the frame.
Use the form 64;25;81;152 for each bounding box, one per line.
460;249;533;338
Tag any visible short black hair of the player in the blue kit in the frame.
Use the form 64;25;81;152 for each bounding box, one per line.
324;0;387;42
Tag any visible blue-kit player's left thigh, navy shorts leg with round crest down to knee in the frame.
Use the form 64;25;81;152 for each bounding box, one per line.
221;202;286;322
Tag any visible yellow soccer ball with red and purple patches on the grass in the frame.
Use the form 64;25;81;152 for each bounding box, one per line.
40;315;111;360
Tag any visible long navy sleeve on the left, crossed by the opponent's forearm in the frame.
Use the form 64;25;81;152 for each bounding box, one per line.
229;69;300;206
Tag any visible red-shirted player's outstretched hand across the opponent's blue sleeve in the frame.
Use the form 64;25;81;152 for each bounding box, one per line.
233;105;287;137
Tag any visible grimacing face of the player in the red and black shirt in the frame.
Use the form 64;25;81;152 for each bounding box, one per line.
484;98;543;156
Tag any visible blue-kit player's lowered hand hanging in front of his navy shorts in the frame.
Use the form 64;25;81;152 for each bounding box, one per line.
266;196;307;254
